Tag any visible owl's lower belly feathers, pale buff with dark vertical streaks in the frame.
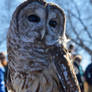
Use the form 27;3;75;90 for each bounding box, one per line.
12;53;62;92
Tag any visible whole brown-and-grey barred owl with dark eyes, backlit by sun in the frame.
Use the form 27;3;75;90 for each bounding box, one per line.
7;0;80;92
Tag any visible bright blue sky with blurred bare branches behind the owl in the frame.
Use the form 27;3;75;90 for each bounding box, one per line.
0;0;92;67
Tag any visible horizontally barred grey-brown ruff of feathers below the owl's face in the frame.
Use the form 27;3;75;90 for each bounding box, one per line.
10;43;53;69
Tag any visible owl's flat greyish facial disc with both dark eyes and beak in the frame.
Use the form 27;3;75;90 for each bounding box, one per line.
18;0;65;46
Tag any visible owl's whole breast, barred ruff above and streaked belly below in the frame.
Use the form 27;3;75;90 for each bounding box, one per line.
10;40;60;92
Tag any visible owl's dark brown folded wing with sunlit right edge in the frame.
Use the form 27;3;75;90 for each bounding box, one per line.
53;48;80;92
